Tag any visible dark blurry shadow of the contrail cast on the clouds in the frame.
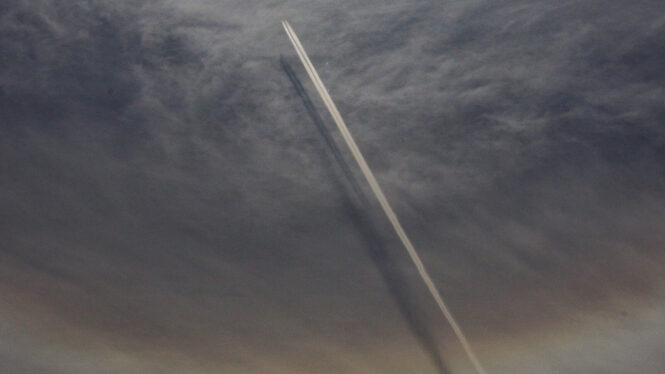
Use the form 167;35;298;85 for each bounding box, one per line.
280;57;450;374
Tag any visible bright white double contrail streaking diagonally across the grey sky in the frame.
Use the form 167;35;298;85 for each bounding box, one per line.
282;21;487;374
